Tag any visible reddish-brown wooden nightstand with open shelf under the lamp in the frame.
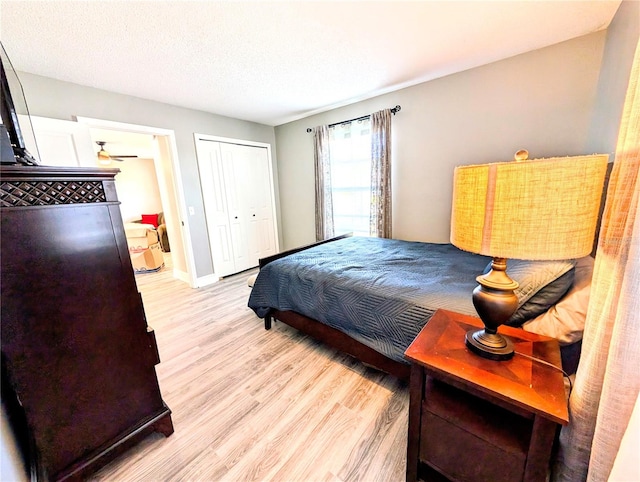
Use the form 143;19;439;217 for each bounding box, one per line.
405;310;569;482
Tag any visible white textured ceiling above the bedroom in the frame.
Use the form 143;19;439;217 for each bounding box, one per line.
0;0;620;125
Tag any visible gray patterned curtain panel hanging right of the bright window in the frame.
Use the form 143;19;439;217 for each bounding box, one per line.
369;109;391;238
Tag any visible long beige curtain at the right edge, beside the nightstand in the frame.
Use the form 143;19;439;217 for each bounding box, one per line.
554;40;640;482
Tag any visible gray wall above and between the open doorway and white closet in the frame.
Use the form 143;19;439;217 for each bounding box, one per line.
19;72;277;277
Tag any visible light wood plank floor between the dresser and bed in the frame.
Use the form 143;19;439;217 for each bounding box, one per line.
93;254;409;482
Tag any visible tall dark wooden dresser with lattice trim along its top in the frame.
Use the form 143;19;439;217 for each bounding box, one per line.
0;166;173;480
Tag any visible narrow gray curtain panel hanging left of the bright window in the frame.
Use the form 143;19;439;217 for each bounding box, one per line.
313;125;334;241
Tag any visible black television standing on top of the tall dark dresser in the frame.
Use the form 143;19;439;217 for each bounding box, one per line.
0;42;38;166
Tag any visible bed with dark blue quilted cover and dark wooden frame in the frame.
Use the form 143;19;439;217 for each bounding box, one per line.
248;235;579;379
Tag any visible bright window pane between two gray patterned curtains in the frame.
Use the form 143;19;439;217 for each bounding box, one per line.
329;118;371;236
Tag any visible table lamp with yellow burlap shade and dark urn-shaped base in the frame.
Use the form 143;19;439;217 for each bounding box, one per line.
451;150;608;360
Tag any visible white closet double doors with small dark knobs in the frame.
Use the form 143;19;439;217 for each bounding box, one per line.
196;135;278;278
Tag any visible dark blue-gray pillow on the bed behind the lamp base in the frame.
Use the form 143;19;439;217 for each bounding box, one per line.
484;259;576;326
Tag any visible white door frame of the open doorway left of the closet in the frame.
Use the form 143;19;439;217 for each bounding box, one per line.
76;116;198;288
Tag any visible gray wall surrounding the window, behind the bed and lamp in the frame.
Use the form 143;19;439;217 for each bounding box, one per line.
276;31;606;248
